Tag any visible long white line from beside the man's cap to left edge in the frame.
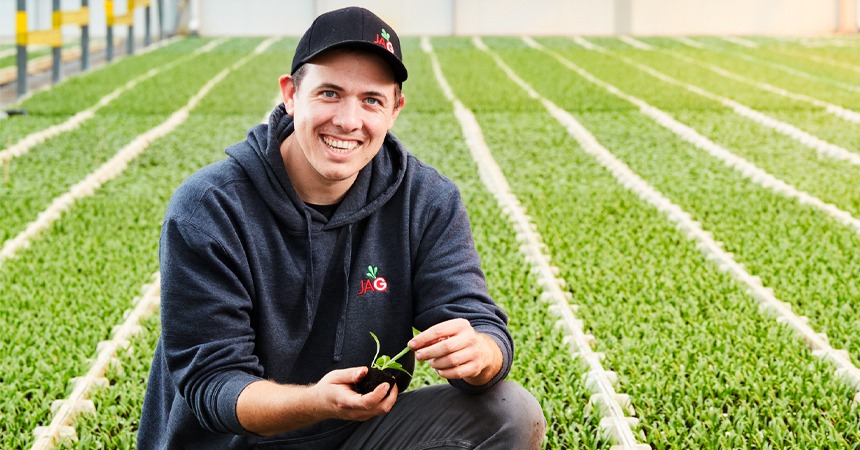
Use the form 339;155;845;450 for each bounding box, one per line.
0;37;278;265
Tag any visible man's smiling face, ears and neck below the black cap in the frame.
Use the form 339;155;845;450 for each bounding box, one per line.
280;49;404;201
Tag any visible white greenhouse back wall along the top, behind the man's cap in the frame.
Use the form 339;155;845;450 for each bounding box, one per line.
0;0;858;42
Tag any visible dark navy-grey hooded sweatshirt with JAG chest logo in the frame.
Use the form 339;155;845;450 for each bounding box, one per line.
138;105;513;449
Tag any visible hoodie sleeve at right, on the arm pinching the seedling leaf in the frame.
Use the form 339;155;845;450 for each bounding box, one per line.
413;176;514;392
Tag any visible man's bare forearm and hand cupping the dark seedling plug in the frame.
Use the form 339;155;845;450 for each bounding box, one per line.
236;367;398;436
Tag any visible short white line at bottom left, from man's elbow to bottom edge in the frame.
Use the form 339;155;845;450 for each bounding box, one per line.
31;272;161;450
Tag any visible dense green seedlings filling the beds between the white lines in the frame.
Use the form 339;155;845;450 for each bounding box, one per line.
0;37;860;449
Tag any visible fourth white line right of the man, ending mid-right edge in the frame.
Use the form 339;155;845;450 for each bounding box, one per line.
608;35;860;166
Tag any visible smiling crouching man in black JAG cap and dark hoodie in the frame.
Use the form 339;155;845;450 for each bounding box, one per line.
138;8;545;449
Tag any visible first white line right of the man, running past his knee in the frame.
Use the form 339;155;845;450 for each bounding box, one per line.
421;37;650;450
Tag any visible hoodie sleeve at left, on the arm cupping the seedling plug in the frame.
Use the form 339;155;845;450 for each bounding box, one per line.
159;212;262;434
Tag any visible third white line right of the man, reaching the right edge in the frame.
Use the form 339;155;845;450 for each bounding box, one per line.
524;38;860;239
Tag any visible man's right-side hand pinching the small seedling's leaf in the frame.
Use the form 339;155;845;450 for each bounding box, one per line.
409;319;502;386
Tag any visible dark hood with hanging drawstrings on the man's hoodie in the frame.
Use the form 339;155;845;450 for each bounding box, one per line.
226;104;407;362
